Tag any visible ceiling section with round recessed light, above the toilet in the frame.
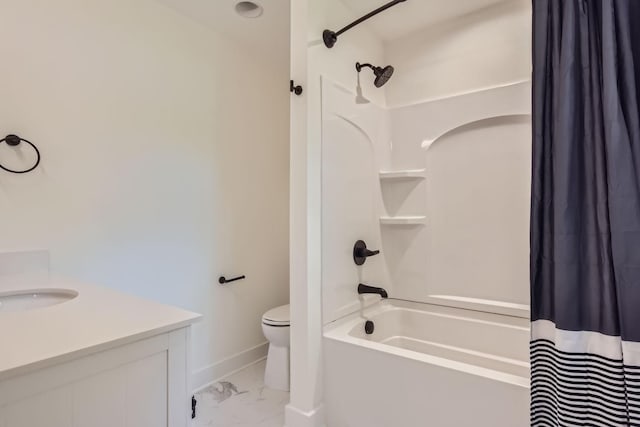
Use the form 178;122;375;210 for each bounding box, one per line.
157;0;289;66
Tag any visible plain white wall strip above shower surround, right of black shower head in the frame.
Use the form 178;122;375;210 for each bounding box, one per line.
385;0;531;106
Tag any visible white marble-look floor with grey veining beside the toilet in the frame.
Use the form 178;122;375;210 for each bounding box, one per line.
192;360;289;427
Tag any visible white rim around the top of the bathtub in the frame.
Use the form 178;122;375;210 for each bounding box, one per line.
323;298;530;389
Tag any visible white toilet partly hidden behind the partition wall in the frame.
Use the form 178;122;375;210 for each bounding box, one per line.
262;304;291;391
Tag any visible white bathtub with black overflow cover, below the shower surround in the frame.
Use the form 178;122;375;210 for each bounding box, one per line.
324;300;529;427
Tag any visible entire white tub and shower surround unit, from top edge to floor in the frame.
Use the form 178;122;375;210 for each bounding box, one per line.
322;78;530;427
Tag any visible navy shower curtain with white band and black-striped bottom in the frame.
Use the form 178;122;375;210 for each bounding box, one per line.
532;0;640;427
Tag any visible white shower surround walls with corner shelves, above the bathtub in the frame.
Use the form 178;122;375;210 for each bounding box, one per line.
322;79;531;323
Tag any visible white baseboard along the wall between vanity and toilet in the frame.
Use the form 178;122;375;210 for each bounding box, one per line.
191;341;269;392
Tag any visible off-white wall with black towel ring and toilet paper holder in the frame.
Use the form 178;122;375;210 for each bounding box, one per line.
0;0;289;386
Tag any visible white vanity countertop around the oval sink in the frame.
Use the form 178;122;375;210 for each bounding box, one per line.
0;278;201;380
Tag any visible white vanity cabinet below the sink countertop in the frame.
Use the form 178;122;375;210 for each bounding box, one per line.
0;325;191;427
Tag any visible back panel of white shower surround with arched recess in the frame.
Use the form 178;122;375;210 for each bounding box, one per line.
390;81;531;308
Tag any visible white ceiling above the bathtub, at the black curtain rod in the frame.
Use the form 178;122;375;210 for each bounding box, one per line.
342;0;511;41
